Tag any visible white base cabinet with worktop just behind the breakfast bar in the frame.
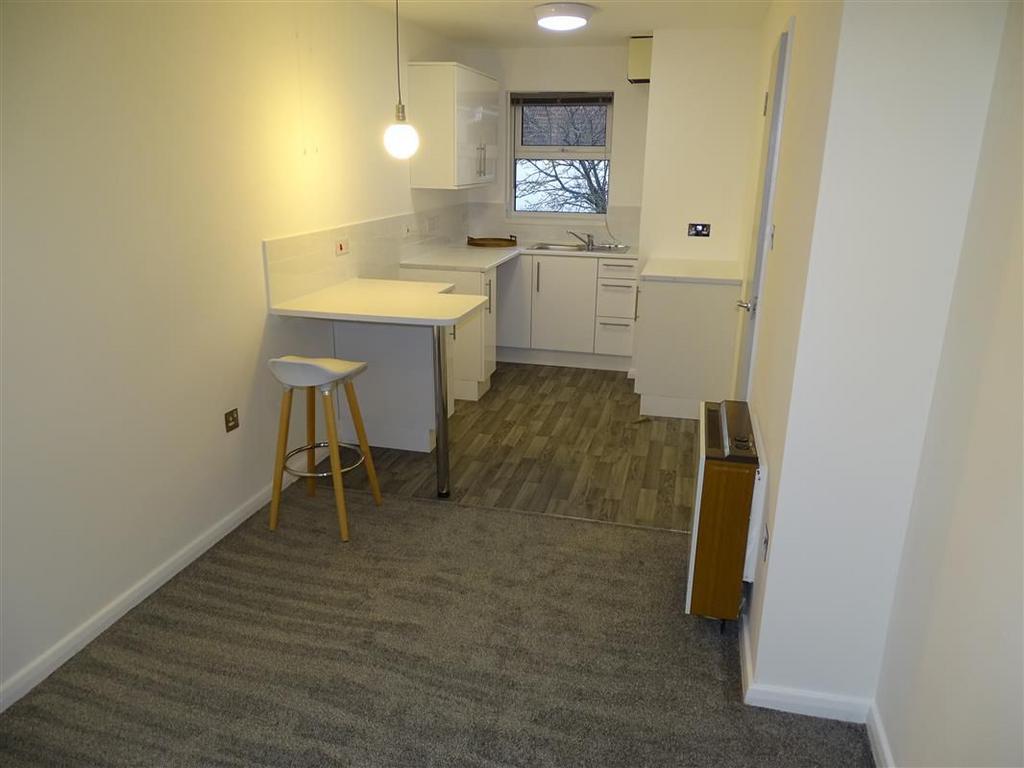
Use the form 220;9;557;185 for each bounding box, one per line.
399;268;498;400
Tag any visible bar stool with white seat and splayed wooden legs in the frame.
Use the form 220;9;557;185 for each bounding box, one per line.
268;354;381;542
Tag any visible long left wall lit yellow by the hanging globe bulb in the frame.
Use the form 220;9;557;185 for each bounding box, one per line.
0;3;465;705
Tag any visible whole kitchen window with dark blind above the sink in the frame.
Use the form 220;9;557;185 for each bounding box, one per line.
510;93;611;215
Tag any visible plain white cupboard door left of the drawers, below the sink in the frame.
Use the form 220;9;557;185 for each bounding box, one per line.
531;256;597;352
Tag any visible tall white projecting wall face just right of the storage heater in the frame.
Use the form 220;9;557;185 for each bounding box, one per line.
748;2;1006;719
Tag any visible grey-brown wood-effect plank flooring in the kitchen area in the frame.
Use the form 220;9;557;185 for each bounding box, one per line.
335;362;697;531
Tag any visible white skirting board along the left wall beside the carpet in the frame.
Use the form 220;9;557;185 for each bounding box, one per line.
0;449;328;712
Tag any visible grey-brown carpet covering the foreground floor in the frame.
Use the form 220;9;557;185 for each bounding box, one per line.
0;485;871;767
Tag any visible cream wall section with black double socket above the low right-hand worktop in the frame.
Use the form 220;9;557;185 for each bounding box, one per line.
640;29;764;262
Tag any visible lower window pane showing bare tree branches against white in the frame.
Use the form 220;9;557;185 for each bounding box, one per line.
515;159;608;213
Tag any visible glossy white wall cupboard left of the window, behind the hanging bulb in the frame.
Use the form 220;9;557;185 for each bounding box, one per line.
407;61;498;189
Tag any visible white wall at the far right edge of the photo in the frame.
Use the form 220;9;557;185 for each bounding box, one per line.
877;3;1024;766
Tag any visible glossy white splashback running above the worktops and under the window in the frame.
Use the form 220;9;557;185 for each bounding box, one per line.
263;203;640;304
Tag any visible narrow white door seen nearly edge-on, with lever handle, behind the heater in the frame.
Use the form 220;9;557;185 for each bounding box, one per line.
735;20;793;400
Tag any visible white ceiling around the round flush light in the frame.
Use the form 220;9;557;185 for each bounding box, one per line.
374;0;770;48
